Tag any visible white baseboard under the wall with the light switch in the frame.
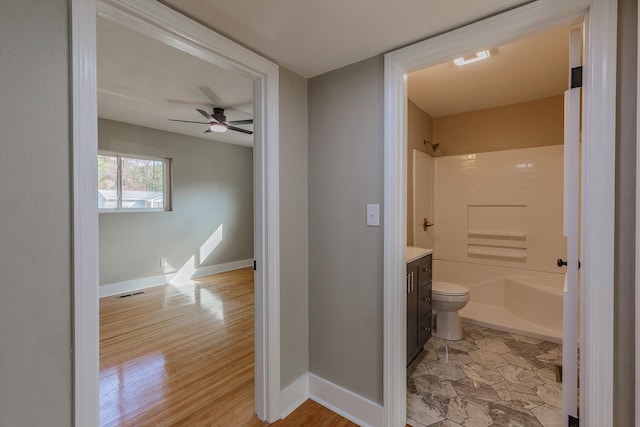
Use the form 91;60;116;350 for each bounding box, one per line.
308;373;384;427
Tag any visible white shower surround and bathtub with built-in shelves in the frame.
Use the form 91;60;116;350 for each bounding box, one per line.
433;145;564;341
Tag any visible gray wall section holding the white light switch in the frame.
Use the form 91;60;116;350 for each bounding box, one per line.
309;56;384;403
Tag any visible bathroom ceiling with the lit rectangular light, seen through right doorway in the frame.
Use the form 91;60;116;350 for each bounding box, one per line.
408;28;569;117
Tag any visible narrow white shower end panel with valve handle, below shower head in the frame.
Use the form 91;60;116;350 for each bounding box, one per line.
413;150;434;249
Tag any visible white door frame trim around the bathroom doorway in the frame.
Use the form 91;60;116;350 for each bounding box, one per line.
383;0;617;427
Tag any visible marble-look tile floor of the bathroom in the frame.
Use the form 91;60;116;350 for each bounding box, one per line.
407;323;562;427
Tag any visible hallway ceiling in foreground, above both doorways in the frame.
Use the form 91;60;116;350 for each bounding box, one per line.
161;0;527;78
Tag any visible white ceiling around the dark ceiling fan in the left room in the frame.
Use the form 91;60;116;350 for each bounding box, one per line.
97;17;253;146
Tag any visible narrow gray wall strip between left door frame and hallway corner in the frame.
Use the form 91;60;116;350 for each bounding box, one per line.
280;67;309;388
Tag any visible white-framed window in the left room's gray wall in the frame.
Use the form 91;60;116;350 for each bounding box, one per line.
98;153;170;212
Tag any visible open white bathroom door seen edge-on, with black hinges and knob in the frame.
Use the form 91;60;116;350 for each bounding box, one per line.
558;27;582;427
